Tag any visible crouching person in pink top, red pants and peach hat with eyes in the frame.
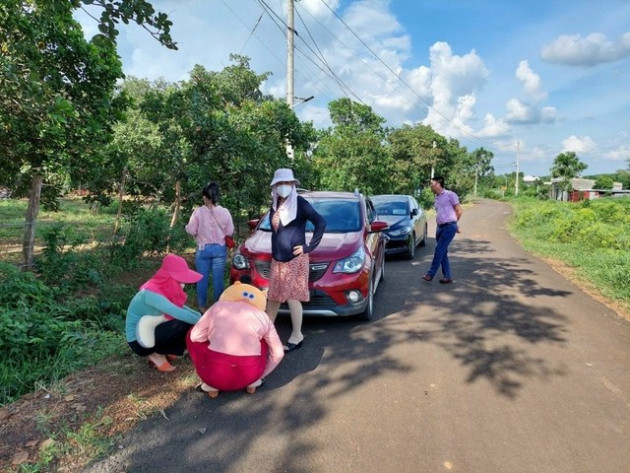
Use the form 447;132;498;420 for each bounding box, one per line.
187;282;284;398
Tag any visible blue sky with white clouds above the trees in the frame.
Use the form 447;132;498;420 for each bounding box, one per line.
77;0;630;176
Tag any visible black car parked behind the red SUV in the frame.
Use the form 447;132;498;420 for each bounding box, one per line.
371;194;427;259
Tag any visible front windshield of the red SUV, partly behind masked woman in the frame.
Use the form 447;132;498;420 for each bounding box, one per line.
258;198;361;233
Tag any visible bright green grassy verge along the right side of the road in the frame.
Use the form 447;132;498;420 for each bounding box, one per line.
510;195;630;314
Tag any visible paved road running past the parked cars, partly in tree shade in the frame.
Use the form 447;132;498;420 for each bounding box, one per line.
86;201;630;473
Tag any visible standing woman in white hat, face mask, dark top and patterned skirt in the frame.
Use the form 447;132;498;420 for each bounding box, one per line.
267;169;326;352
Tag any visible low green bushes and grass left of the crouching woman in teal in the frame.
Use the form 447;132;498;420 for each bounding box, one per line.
0;263;131;405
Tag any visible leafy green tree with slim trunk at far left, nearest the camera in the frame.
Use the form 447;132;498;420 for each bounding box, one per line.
0;0;175;267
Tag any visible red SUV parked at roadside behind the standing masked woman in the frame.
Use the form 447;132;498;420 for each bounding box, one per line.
230;192;387;320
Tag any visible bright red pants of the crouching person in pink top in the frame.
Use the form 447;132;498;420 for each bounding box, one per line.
186;332;269;391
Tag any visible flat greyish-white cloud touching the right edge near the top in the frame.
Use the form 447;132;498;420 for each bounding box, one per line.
540;32;630;67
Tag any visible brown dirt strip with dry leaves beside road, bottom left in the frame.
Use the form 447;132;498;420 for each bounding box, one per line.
0;354;197;473
